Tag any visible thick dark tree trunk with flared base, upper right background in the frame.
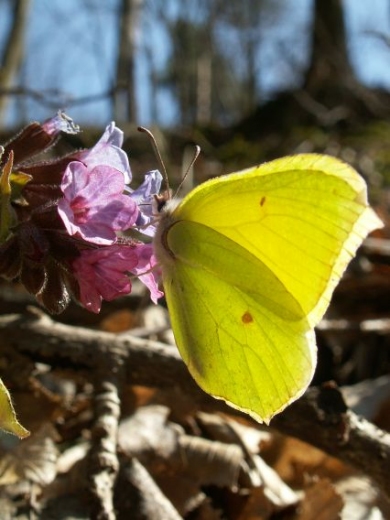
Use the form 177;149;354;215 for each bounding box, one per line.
305;0;356;94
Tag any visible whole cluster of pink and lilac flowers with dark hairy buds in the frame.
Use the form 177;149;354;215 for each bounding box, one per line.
0;113;162;313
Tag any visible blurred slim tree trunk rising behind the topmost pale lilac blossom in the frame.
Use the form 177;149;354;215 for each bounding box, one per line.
114;0;144;123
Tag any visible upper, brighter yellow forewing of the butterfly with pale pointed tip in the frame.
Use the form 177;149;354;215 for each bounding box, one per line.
174;154;382;327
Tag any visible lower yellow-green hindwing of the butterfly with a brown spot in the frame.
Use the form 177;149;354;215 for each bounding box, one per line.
163;222;316;422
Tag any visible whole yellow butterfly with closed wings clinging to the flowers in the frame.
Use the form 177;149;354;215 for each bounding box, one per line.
154;154;381;422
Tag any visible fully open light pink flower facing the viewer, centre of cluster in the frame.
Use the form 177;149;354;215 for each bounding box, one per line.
58;161;139;245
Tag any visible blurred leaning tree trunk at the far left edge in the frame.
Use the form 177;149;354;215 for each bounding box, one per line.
0;0;30;127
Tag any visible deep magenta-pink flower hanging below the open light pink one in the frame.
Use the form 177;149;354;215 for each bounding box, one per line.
72;245;138;313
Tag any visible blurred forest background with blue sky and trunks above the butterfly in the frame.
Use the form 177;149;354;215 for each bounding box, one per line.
0;0;390;194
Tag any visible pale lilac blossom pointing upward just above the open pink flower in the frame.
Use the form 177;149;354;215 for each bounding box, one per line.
74;122;131;184
